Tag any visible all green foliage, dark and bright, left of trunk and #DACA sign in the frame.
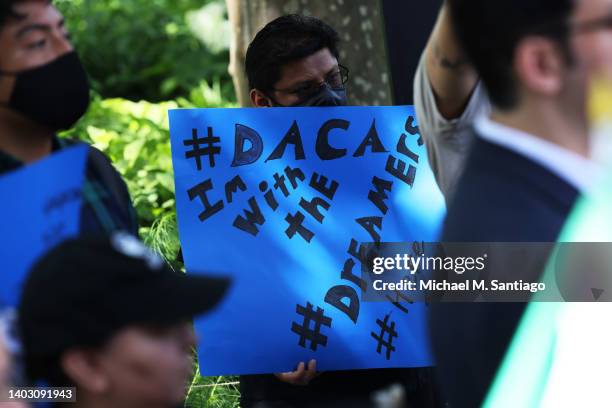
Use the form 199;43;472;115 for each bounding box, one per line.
54;0;239;408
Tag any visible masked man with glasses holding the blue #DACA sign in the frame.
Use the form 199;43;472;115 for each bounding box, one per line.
240;15;436;407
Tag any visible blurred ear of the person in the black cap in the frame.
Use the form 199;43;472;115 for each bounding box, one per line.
60;350;109;394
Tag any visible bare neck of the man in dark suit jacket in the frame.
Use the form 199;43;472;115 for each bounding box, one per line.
491;101;590;158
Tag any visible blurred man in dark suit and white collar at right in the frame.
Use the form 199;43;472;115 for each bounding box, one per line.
431;0;612;407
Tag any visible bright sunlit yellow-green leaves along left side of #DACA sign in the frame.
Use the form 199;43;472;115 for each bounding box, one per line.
64;82;235;266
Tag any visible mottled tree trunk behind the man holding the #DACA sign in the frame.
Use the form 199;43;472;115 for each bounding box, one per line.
226;0;392;106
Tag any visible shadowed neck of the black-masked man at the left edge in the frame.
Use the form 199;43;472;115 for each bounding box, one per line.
0;111;54;163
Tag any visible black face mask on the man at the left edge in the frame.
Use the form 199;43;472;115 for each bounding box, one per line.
0;51;89;131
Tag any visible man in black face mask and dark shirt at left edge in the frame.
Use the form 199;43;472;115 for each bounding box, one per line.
0;0;138;234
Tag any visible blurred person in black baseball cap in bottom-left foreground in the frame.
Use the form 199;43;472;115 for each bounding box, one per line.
19;233;228;408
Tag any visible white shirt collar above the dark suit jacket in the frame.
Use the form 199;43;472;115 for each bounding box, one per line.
474;115;601;193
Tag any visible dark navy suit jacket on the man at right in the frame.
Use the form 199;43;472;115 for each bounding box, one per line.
430;132;578;408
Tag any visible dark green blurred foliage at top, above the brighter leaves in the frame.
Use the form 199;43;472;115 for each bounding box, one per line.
54;0;234;102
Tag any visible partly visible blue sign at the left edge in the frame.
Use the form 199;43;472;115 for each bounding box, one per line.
0;146;87;307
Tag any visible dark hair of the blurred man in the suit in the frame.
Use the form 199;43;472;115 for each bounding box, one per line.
448;0;574;110
